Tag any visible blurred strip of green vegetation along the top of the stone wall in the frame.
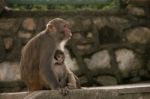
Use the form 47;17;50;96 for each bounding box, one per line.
8;0;117;11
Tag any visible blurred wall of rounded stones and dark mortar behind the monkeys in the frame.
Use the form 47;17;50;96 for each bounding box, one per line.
0;11;150;92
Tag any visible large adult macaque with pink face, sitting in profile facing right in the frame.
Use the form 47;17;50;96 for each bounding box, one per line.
21;18;78;94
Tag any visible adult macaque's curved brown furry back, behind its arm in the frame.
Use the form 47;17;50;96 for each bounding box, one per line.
20;32;50;87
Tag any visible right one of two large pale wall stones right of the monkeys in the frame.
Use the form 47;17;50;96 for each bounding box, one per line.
115;49;142;77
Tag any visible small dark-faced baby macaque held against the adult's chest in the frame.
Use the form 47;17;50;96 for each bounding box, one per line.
54;50;80;89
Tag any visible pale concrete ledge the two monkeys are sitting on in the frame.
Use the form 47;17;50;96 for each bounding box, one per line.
0;84;150;99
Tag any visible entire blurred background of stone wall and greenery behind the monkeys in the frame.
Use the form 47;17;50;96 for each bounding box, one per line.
0;0;150;92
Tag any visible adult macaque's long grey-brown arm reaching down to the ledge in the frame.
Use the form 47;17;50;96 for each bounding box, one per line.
39;38;60;89
